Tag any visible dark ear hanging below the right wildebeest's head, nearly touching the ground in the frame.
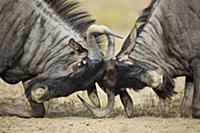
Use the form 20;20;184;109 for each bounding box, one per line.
119;90;133;117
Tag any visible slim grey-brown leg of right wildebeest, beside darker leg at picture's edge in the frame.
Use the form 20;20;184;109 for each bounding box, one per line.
180;77;194;117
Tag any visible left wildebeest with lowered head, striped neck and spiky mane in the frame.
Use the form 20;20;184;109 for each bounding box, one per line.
0;0;119;117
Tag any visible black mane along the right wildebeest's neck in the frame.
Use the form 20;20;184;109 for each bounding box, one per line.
136;0;157;34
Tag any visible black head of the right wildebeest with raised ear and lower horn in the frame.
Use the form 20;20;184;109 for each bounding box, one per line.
79;27;174;117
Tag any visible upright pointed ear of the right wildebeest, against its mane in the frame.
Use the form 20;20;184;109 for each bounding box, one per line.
118;26;137;56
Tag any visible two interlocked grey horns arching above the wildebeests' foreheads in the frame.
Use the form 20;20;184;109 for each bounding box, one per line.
87;24;122;60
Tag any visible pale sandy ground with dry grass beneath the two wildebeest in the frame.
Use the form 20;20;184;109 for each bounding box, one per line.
0;80;200;133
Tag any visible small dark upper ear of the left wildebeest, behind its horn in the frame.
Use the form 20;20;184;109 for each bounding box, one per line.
68;38;87;53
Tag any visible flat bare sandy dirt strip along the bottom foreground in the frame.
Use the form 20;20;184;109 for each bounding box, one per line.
0;116;200;133
